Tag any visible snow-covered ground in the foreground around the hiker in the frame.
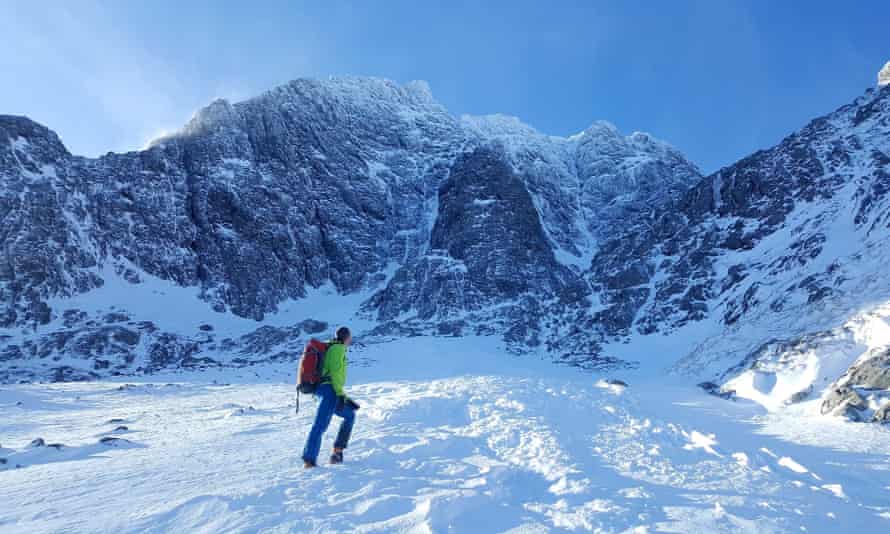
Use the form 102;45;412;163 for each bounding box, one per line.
0;338;890;533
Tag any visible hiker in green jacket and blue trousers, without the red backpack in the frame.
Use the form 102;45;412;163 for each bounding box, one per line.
303;326;358;468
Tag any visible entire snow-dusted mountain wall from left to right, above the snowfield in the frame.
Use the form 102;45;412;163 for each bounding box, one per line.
0;71;890;430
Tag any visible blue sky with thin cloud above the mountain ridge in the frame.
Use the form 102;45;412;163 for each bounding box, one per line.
0;0;890;171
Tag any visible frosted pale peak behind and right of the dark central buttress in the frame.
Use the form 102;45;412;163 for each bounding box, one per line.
462;115;701;262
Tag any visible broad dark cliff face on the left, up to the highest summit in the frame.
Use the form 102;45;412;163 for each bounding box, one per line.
3;81;458;327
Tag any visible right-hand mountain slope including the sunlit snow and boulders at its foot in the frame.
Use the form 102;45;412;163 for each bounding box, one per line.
589;80;890;422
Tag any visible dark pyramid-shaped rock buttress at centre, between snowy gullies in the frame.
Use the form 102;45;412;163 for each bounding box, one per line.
369;148;583;321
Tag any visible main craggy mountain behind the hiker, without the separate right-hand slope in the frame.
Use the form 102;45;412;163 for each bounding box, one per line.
0;78;700;381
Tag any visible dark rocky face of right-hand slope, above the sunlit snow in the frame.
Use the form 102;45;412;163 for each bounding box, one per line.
590;84;890;342
